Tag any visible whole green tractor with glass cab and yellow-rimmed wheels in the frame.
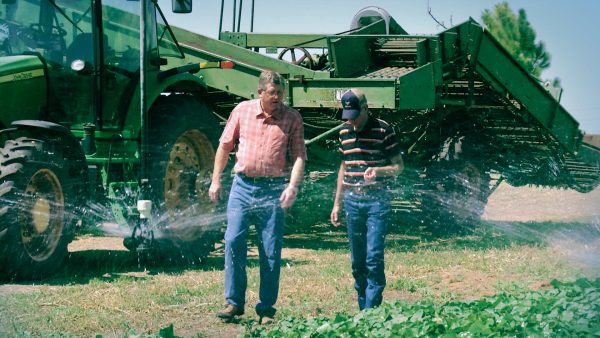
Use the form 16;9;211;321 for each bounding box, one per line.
0;0;220;279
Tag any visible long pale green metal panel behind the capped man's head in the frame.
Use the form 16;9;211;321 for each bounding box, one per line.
289;79;397;109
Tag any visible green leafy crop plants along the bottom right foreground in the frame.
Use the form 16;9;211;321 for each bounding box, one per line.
247;279;600;337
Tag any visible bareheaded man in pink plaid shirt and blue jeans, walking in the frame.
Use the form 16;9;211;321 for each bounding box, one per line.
209;71;306;324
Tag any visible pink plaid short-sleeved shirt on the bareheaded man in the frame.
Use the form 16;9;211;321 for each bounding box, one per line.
219;99;306;177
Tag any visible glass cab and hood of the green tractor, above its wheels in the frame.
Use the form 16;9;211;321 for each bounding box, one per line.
0;0;188;130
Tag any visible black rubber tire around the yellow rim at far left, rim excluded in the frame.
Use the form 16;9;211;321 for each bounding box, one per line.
0;137;83;280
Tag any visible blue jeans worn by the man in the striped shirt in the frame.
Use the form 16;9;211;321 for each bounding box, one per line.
344;189;390;310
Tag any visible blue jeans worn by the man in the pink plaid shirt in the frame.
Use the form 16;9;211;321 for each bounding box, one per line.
225;175;286;316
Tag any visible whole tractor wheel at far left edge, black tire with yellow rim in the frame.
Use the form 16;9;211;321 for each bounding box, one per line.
0;137;84;280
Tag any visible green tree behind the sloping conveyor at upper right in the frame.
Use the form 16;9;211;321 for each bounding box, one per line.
481;1;560;79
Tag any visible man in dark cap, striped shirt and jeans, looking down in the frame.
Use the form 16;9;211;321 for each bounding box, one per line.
331;89;403;310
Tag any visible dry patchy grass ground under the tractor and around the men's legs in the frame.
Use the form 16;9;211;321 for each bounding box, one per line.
0;222;600;337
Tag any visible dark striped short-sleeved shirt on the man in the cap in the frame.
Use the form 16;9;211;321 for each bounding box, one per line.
339;116;400;186
